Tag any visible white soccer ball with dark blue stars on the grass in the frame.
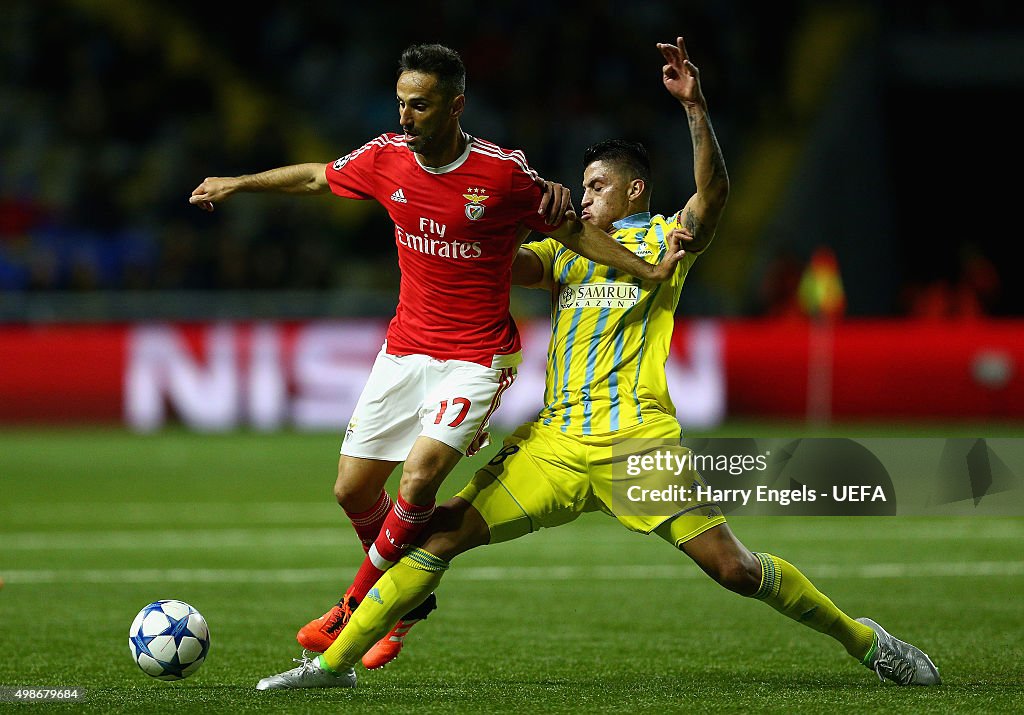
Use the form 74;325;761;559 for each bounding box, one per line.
128;600;210;680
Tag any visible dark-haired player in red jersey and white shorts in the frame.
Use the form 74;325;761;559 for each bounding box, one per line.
189;45;684;651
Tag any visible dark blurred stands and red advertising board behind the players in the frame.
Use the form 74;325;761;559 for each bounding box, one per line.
0;0;1024;428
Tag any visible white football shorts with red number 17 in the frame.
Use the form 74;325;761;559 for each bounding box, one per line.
341;345;516;462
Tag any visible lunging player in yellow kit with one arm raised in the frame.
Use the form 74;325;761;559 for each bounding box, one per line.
257;38;940;689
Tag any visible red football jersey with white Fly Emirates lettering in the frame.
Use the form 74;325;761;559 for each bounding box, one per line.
327;134;553;367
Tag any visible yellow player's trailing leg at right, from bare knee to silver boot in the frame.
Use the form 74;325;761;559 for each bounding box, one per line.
657;523;941;685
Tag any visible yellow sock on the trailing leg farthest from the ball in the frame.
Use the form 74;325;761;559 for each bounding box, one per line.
754;553;874;662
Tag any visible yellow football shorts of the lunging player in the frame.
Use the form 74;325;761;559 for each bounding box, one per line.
457;415;725;547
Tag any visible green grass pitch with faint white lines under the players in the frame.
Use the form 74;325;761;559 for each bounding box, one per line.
0;426;1024;713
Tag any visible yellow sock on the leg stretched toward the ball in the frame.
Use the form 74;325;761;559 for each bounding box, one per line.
319;549;449;672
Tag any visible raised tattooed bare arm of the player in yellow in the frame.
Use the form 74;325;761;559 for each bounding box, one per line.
657;37;729;253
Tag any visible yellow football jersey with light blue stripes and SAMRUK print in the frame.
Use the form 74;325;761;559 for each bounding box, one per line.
523;213;696;434
